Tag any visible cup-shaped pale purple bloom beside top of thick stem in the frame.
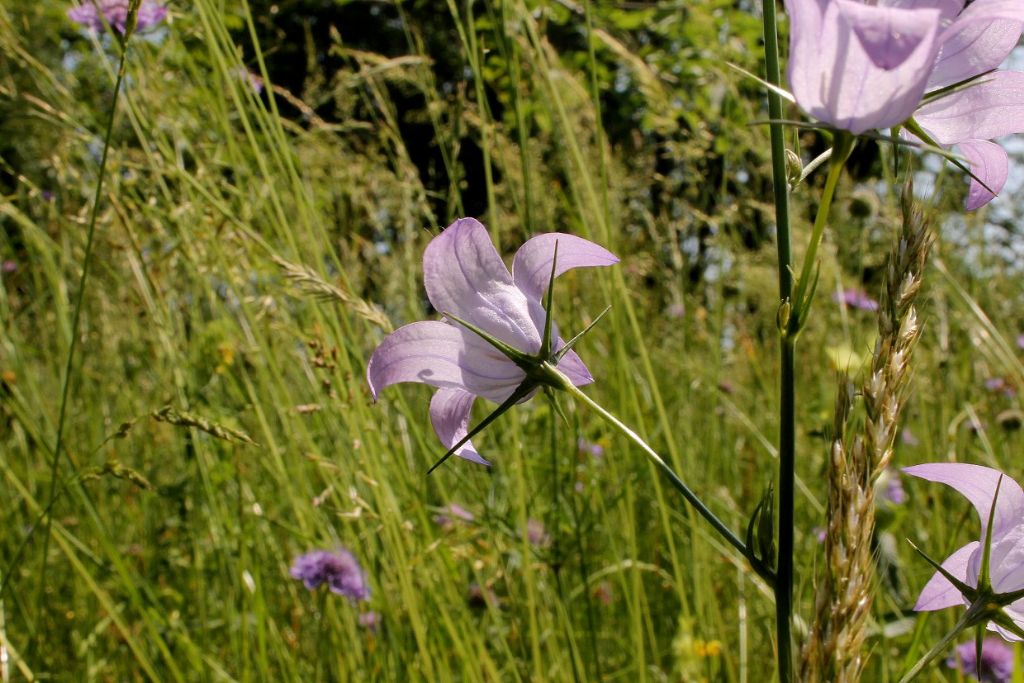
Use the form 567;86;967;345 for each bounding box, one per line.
788;0;941;134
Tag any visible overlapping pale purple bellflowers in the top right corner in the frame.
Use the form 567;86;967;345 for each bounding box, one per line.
786;0;1024;210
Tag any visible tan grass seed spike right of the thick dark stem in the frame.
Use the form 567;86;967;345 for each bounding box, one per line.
801;185;932;683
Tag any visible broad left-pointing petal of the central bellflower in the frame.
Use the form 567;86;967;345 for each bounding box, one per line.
367;321;526;402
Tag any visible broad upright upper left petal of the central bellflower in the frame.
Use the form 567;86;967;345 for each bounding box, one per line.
423;218;544;353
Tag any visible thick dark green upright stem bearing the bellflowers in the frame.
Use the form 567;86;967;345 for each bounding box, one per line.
762;0;796;683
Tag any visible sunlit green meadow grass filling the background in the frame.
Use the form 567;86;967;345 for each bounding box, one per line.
0;0;1024;682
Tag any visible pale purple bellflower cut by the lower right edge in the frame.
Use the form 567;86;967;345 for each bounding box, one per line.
903;463;1024;640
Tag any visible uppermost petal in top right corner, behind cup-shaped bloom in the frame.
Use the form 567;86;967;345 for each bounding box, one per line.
928;7;1024;90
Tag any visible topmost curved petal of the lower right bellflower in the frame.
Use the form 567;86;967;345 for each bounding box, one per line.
903;463;1024;538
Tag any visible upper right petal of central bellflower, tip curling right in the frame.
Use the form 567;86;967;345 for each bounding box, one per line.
512;232;618;301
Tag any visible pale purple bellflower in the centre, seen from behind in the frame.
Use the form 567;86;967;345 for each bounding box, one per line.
367;218;618;465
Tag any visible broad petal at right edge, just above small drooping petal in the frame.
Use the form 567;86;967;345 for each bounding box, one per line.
914;70;1024;144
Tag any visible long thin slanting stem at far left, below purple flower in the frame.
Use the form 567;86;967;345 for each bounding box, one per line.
36;7;140;630
